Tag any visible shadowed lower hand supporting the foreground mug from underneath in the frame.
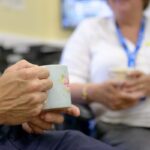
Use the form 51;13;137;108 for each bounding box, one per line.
22;105;80;134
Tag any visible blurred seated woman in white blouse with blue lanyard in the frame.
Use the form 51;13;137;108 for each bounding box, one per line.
61;0;150;150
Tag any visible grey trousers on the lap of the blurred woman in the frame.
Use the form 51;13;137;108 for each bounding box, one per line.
98;123;150;150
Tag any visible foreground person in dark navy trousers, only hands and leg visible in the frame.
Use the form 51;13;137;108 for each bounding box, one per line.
0;61;117;150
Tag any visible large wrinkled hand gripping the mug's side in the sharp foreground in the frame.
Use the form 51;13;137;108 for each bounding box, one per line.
0;60;52;125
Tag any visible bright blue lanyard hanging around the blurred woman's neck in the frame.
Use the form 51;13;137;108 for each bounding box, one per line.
116;18;145;68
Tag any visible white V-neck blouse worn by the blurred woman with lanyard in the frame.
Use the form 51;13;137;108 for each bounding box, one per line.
61;17;150;127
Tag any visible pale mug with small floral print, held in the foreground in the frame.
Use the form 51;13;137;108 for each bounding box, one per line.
44;65;71;110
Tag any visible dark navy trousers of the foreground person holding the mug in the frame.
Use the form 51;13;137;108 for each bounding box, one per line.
0;126;115;150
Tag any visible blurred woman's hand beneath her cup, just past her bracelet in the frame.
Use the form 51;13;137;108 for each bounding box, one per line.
88;81;141;110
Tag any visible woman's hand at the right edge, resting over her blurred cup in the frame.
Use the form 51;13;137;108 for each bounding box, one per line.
124;71;150;97
